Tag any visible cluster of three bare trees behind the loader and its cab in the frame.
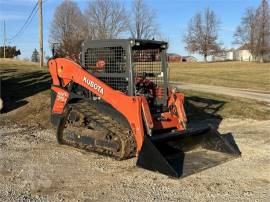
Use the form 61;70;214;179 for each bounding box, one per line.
50;0;159;59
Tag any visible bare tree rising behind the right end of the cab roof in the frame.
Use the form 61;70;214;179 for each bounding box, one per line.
129;0;159;39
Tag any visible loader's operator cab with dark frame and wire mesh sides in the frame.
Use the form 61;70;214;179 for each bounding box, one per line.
82;39;168;110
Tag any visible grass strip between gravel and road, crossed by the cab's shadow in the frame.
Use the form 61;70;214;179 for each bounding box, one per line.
184;90;270;120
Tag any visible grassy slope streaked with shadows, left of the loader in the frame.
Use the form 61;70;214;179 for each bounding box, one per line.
0;59;51;112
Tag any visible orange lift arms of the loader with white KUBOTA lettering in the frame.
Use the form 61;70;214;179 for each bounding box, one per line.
48;58;186;152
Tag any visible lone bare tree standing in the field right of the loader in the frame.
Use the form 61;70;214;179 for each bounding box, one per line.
184;8;221;62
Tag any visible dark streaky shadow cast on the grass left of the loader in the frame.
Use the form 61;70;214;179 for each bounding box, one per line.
1;69;50;113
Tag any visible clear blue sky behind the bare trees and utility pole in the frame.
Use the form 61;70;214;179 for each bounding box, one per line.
0;0;260;58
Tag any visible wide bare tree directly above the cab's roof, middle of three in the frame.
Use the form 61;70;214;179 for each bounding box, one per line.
85;0;128;39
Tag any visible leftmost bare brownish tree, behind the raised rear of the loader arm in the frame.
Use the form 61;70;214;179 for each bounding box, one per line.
50;0;87;59
